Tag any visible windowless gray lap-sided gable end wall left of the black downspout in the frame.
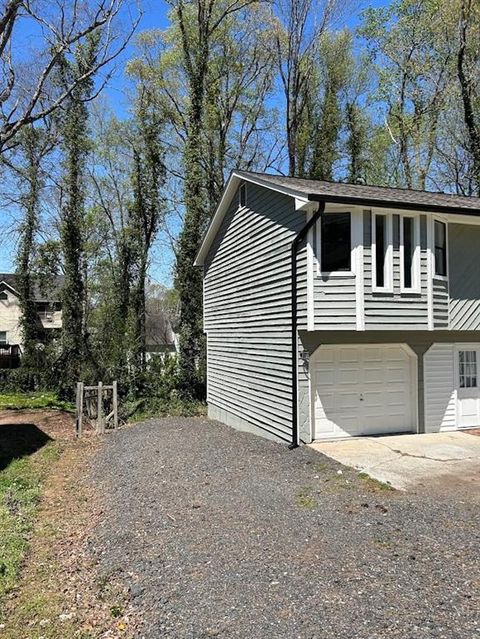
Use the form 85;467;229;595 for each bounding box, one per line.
204;184;306;439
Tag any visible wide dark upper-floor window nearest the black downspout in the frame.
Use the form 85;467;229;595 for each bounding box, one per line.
320;213;352;273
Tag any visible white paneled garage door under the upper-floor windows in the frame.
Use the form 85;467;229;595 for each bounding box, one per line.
312;344;416;438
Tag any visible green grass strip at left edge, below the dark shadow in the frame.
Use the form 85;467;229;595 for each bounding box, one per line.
0;442;60;618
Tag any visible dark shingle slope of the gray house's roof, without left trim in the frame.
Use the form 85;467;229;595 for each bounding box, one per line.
235;171;480;215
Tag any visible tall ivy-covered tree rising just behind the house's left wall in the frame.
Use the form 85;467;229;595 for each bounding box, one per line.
162;0;256;397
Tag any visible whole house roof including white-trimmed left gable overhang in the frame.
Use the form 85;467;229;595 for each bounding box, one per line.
195;171;480;266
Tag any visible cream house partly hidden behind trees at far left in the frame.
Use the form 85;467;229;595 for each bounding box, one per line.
0;273;62;368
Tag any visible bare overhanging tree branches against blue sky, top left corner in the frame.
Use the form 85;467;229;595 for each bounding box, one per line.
0;0;139;153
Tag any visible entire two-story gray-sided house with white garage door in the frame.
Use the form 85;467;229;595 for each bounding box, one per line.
196;171;480;445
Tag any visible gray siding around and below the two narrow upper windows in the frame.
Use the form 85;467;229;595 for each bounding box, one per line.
364;211;428;330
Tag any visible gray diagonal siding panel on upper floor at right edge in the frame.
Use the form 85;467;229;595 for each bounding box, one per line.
448;224;480;331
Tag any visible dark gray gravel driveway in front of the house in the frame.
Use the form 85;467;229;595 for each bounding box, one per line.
92;418;480;639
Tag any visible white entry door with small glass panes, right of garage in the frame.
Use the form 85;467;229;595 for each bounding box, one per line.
457;345;480;428
